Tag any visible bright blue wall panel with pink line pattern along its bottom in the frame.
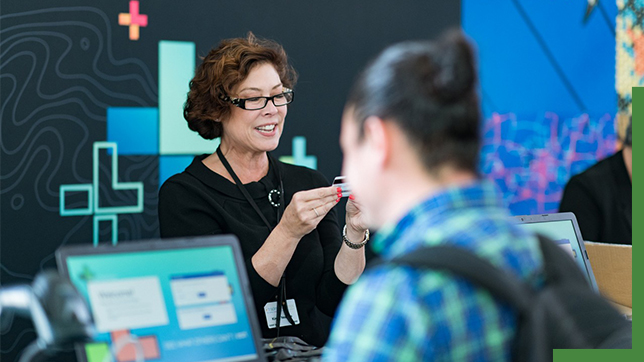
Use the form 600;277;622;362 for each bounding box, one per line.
462;0;620;215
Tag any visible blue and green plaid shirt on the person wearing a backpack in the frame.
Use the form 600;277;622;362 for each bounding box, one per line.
323;182;542;362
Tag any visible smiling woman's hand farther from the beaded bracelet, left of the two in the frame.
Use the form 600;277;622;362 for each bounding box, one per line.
280;186;341;239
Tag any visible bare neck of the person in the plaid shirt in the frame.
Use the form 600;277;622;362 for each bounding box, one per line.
378;165;476;225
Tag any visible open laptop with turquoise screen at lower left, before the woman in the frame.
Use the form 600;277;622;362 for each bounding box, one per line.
56;235;265;362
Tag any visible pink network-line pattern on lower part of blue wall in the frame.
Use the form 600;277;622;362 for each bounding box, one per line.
481;113;615;215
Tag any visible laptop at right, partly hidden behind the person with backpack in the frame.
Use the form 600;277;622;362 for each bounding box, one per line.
515;212;599;293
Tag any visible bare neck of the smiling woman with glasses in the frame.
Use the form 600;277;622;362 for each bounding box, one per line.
204;141;269;184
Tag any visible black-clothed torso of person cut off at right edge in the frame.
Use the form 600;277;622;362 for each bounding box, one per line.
559;118;633;244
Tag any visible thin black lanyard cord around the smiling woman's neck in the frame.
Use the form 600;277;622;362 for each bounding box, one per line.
217;147;295;337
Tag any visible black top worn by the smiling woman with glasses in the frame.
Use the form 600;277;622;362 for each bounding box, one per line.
159;155;347;346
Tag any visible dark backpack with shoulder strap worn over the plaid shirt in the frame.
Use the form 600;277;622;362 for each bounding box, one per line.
376;235;632;361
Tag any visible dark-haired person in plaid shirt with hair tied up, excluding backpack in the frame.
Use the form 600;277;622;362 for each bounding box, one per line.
323;32;543;362
